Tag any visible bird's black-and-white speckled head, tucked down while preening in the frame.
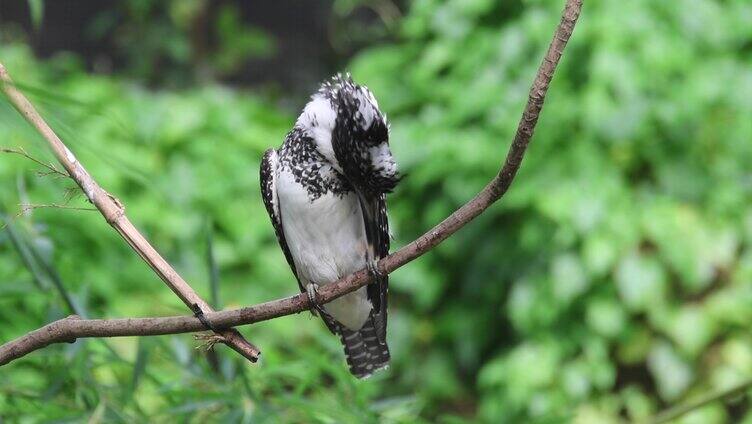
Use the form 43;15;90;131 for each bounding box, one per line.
297;74;400;194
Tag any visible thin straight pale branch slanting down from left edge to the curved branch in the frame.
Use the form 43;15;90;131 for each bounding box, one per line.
0;64;261;362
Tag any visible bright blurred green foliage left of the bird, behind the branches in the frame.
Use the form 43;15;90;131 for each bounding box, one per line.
0;46;419;422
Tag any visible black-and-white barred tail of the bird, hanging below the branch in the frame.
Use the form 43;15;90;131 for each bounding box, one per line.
339;316;390;378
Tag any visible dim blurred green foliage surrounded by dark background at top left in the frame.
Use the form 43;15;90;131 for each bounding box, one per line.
86;0;276;87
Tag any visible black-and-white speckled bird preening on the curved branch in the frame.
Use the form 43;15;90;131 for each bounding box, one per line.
260;74;401;379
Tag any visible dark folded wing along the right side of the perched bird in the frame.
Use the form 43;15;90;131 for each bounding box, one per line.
359;193;390;343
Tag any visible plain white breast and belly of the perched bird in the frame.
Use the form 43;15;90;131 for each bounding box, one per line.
277;170;371;330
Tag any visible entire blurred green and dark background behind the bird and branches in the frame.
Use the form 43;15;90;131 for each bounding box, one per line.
0;0;752;423
